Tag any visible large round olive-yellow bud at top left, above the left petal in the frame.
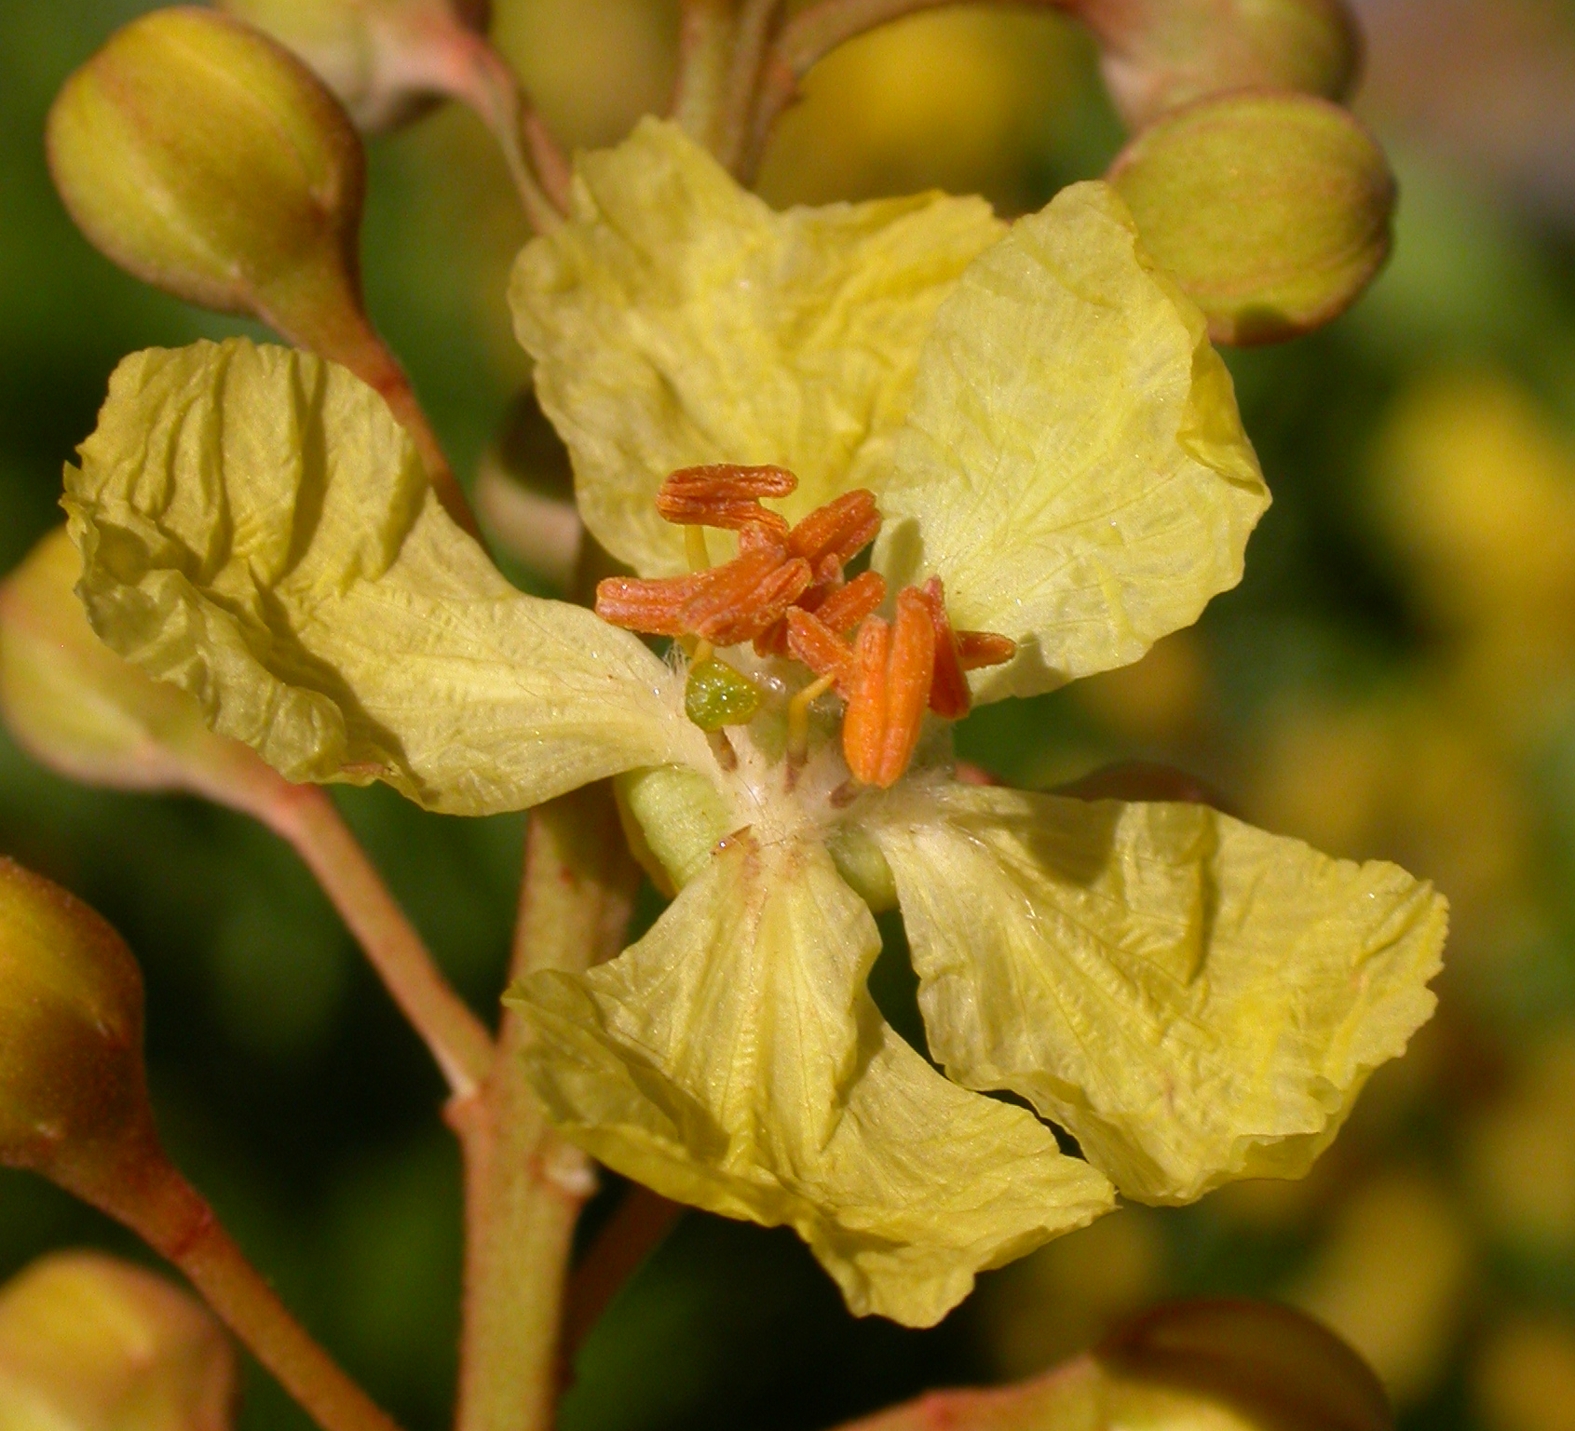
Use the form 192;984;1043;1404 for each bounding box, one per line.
47;8;365;351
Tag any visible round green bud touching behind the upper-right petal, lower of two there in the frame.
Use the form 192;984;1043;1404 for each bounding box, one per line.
1110;91;1395;343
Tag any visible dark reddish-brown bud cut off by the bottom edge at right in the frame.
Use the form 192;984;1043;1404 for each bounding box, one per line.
1095;1300;1394;1431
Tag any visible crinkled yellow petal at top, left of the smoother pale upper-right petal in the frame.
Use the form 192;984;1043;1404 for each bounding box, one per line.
509;120;1005;575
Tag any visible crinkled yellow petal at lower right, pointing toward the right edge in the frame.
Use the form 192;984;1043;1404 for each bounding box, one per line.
871;786;1446;1203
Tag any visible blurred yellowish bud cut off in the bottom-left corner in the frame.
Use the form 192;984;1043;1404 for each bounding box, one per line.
0;1252;235;1431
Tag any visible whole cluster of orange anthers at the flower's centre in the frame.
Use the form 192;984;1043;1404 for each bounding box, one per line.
595;464;1016;789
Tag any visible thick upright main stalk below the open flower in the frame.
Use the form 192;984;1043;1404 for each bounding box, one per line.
447;786;638;1431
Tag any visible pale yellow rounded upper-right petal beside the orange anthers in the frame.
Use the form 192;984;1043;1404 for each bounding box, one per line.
876;183;1269;701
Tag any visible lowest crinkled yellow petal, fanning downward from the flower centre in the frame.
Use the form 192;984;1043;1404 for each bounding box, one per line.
510;833;1114;1326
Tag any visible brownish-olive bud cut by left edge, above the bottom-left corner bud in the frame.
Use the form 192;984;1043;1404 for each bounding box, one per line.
0;858;151;1182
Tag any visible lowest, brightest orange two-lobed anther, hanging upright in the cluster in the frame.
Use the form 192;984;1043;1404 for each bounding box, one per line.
843;587;936;790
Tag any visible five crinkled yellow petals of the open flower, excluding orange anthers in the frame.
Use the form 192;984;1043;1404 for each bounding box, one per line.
66;121;1444;1324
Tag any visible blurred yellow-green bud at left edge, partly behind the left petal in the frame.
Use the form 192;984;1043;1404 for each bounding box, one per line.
0;527;279;809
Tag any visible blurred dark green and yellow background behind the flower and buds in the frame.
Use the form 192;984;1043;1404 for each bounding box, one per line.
0;0;1575;1431
